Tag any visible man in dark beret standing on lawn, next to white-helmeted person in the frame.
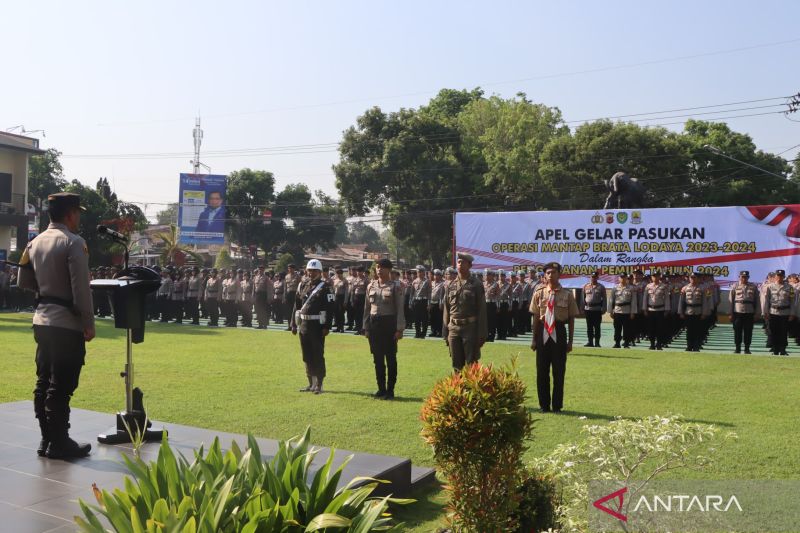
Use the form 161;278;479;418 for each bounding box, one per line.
364;258;406;400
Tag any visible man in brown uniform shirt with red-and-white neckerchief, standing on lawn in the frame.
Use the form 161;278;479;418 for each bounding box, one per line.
531;262;578;413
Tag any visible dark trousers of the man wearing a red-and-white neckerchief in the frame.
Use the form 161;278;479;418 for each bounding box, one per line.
536;321;567;411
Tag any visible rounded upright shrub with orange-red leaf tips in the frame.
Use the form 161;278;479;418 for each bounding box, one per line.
421;363;532;533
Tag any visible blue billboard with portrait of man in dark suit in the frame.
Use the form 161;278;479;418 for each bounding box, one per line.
178;174;228;244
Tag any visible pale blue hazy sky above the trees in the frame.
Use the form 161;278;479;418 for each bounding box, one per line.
0;0;800;215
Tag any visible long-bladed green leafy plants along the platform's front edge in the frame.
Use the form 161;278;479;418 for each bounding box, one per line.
75;430;408;533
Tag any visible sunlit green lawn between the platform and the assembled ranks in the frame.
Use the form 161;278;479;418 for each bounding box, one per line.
0;314;800;532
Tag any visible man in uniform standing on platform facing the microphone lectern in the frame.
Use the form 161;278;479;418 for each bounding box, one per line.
17;193;95;459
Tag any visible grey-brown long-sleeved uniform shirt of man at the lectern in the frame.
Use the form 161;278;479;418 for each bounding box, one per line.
17;223;94;331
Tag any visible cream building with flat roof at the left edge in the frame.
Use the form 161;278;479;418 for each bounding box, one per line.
0;131;44;259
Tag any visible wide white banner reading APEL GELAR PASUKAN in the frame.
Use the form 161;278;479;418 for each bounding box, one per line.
455;205;800;288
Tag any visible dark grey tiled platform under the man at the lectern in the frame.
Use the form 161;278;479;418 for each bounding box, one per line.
0;401;435;533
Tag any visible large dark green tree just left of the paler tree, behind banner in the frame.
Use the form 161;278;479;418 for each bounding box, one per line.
334;89;486;265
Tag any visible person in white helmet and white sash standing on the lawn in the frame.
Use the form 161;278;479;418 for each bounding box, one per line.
289;259;334;394
